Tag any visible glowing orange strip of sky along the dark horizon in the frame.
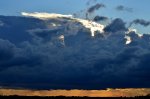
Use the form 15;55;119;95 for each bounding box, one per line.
0;88;150;97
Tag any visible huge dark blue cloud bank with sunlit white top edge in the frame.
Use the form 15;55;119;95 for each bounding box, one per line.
0;12;150;89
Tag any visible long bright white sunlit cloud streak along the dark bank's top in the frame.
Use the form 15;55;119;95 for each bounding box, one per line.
21;12;104;36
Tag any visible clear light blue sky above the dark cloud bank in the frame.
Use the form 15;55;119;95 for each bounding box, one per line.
0;0;150;33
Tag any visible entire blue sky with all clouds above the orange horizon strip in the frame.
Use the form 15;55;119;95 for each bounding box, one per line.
0;0;150;93
